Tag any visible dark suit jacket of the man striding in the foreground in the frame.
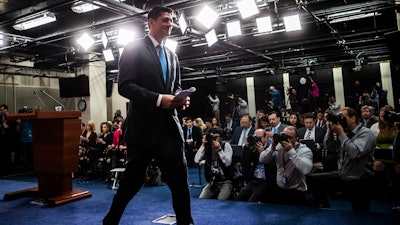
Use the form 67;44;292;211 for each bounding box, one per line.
118;36;184;146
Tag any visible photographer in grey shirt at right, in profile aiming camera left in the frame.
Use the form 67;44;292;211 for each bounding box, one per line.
324;107;375;211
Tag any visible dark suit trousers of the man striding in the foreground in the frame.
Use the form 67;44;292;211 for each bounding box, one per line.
103;123;192;225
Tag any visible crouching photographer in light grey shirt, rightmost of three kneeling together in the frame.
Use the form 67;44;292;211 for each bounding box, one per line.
259;126;313;205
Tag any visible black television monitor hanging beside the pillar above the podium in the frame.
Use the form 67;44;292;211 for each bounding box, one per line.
58;75;90;98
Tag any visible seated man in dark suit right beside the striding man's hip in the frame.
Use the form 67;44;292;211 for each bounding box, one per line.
183;117;202;167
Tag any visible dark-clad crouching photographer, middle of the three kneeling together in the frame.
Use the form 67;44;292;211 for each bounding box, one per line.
235;129;276;202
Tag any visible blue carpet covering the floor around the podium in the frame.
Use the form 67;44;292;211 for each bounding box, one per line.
0;170;400;225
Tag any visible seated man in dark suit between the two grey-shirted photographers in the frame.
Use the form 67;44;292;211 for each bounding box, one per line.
298;113;326;163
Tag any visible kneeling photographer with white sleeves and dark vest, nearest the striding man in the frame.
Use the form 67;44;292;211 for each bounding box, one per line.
194;129;233;200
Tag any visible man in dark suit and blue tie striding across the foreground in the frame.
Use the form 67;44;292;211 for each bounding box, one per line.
103;7;193;225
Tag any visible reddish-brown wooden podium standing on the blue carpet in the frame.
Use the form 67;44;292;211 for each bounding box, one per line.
4;111;92;206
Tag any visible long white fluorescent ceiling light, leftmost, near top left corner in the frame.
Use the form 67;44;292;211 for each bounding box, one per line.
13;12;57;30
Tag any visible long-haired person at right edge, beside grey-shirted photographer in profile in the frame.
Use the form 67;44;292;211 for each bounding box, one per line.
371;105;397;199
